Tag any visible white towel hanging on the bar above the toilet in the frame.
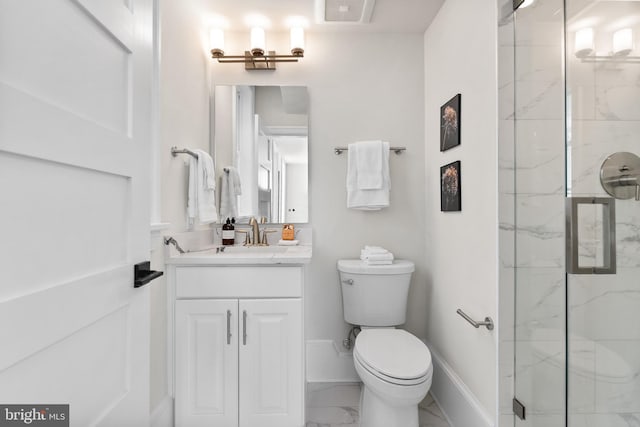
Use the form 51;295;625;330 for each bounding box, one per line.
347;141;391;210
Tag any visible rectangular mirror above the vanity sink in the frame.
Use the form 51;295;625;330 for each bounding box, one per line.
212;85;309;223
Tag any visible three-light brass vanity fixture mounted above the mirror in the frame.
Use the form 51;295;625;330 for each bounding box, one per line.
210;27;304;70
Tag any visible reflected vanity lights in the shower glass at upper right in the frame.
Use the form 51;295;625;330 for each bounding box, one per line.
574;28;640;62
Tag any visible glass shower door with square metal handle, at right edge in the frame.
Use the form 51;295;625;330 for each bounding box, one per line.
565;0;640;427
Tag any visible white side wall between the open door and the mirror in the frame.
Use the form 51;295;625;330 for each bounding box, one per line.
150;0;209;410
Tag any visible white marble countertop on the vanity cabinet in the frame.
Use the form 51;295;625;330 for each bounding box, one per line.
165;245;312;265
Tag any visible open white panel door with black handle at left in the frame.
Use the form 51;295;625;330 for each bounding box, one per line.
0;0;153;427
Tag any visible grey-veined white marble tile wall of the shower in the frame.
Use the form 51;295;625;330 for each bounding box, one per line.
499;0;640;427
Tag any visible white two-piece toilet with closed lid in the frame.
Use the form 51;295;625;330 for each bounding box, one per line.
338;259;433;427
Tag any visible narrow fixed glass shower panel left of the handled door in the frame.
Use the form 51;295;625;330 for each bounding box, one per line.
514;0;566;427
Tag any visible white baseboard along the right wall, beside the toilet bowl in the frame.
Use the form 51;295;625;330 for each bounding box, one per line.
427;343;495;427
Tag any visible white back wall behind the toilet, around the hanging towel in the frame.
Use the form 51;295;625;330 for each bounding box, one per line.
211;29;427;374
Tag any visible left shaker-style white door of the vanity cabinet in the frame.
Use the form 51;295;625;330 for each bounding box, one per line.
175;299;238;427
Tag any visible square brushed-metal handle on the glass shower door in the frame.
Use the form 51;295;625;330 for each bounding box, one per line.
565;197;616;274
